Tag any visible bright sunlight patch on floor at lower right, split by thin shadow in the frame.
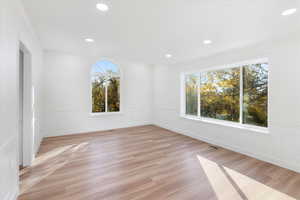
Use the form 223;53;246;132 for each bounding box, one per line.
197;155;296;200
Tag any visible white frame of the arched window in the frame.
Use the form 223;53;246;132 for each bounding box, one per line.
89;58;123;115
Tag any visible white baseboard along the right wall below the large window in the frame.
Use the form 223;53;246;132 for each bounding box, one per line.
155;124;300;173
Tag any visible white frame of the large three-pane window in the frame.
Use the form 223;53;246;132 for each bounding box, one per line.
180;58;270;133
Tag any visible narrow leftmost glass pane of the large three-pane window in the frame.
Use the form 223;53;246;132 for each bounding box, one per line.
185;74;199;115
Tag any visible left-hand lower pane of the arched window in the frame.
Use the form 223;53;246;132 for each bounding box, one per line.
92;76;105;113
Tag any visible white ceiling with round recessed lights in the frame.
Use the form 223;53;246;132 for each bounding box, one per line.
23;0;300;63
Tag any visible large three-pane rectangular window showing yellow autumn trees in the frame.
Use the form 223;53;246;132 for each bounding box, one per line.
185;60;268;127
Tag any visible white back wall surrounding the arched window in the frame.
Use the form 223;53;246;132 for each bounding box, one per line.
41;51;152;136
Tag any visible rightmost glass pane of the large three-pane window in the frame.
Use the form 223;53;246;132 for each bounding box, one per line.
243;63;268;127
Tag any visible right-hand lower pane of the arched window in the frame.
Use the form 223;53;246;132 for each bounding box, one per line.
107;77;120;112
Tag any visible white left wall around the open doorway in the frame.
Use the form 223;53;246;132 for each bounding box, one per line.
0;0;42;200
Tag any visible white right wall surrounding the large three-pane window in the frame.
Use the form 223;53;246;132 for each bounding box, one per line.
153;34;300;172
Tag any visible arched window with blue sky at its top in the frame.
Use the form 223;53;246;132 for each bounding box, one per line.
91;60;120;113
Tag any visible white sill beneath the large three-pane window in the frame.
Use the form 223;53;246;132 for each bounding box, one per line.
181;115;269;134
